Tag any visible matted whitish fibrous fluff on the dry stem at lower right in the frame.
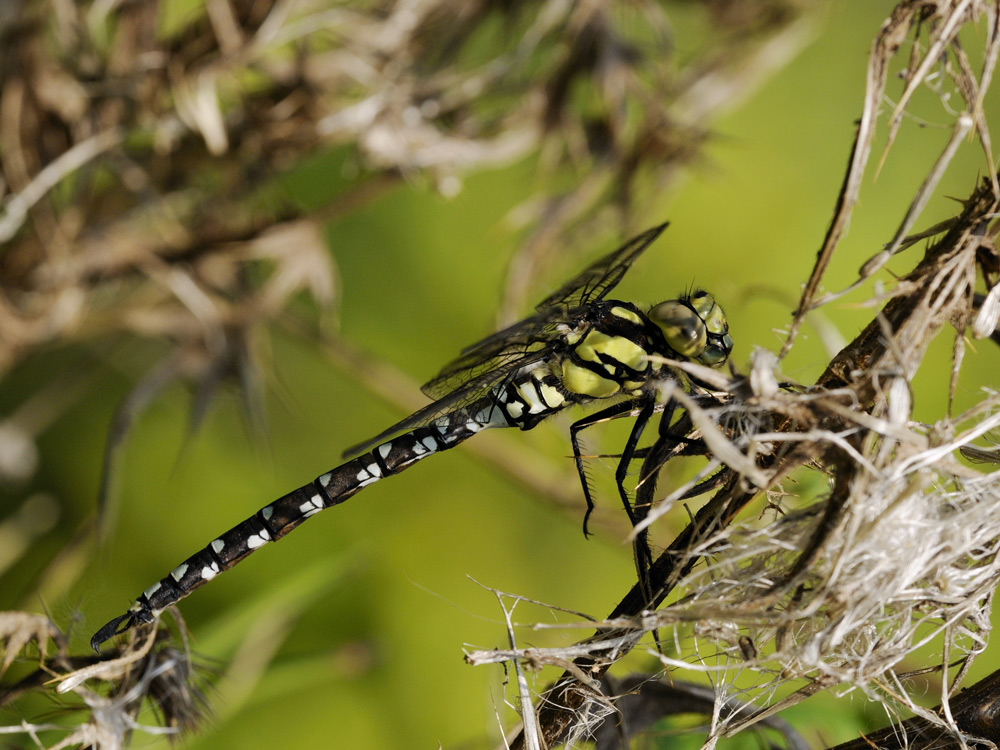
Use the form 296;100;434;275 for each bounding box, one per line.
644;397;1000;736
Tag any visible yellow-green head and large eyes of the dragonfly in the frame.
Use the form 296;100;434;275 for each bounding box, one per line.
647;290;733;367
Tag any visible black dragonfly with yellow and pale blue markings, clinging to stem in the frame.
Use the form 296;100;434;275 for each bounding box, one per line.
91;223;733;652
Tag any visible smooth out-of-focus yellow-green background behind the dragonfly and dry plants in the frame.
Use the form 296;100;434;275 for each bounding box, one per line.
0;2;1000;748
